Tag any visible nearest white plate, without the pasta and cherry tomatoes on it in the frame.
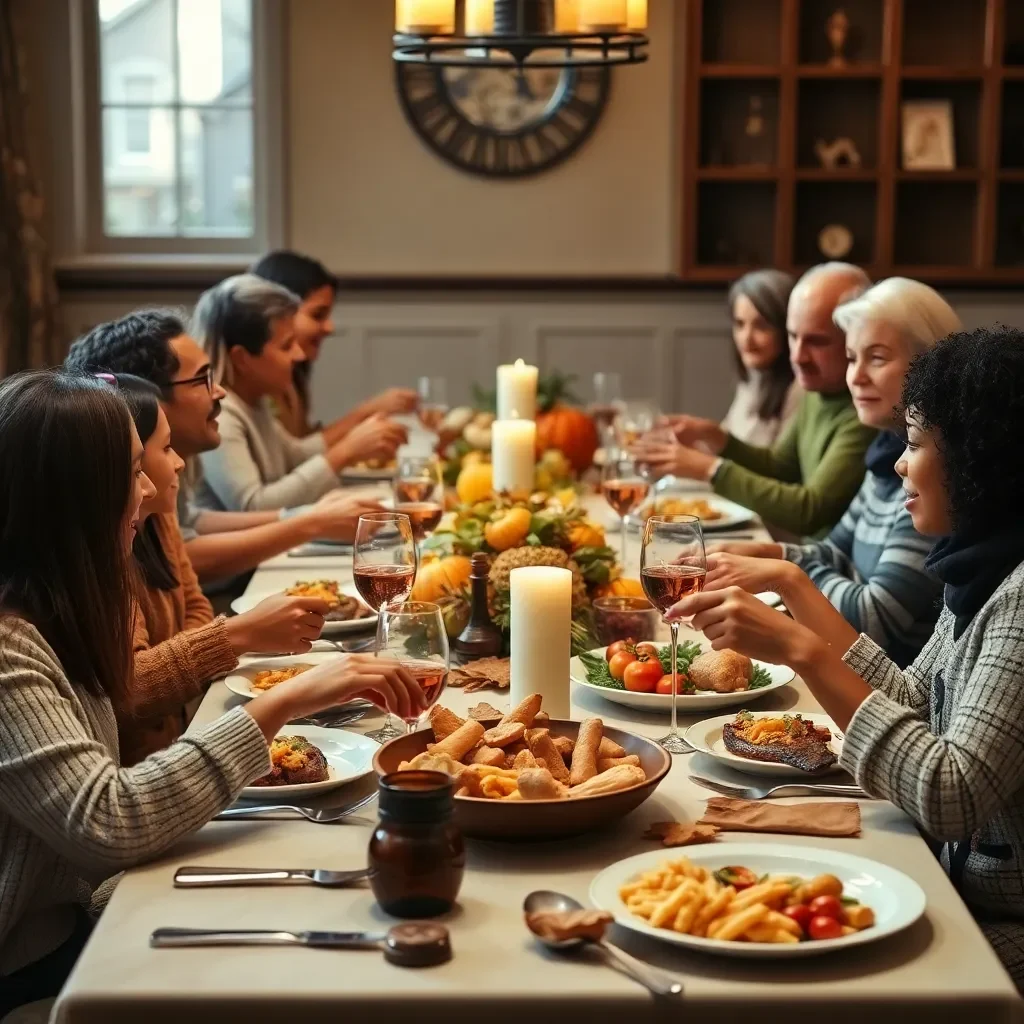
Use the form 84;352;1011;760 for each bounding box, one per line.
590;843;926;959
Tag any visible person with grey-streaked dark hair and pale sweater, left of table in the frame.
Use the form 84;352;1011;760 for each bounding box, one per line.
193;273;406;511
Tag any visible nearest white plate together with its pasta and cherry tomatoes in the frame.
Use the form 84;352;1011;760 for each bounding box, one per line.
590;843;926;959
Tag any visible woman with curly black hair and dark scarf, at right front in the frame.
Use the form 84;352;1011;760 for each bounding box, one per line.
670;329;1024;987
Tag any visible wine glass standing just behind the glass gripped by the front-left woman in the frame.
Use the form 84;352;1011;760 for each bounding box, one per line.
352;512;417;743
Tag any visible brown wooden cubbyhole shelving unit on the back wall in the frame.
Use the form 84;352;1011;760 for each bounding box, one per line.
682;0;1024;286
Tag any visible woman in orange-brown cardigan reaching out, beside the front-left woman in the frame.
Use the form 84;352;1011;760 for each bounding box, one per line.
115;374;328;767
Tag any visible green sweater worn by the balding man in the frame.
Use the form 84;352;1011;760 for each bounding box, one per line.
712;391;876;537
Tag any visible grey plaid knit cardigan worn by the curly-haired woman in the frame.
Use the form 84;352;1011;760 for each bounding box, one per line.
840;563;1024;987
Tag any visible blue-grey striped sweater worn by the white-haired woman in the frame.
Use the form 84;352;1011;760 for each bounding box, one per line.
782;473;942;667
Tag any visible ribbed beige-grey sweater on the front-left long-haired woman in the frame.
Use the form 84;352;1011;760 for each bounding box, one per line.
0;617;270;985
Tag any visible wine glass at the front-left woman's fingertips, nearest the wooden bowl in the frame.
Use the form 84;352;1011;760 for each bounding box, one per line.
377;601;450;735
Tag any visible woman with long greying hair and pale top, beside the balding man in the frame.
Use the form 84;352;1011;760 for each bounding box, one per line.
722;270;802;447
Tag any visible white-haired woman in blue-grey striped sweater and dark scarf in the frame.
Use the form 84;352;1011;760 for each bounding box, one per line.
707;278;962;667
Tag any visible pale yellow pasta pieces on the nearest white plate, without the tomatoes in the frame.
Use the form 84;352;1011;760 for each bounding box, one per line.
618;857;874;944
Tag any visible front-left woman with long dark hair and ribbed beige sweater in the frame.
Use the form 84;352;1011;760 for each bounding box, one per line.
0;371;423;1018
